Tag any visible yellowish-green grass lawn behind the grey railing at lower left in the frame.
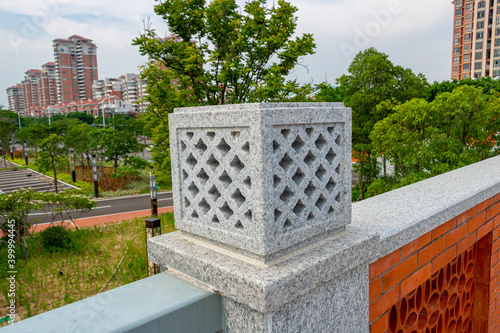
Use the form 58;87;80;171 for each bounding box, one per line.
0;213;175;326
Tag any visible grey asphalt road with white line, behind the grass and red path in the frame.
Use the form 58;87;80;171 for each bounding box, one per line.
28;192;174;223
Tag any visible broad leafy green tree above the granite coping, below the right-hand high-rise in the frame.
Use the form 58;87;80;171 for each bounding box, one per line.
371;85;500;186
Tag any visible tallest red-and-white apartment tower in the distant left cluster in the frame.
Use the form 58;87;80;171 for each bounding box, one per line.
52;35;99;103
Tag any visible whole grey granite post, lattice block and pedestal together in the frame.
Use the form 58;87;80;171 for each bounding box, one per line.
148;103;374;332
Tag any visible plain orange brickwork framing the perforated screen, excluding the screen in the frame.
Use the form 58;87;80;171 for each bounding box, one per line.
369;194;500;333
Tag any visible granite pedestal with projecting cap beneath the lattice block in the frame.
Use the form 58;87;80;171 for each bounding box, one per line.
148;227;378;333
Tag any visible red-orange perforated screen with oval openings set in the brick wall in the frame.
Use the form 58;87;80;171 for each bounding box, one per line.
389;243;477;333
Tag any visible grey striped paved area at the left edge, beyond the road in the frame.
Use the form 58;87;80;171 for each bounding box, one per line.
0;167;77;194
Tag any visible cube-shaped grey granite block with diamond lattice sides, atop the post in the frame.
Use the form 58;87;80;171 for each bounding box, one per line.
169;103;351;261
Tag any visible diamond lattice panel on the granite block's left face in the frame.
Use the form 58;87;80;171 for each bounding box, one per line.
178;128;252;232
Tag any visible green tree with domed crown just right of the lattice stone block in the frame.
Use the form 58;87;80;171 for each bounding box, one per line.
337;48;427;198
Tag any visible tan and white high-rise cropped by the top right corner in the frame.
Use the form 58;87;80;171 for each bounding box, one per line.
451;0;500;80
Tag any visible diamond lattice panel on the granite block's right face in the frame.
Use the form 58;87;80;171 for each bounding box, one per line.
272;124;344;232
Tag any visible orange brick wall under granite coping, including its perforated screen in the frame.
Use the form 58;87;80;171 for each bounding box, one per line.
369;194;500;333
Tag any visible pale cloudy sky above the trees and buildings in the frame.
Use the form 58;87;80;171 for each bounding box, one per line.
0;0;453;107
